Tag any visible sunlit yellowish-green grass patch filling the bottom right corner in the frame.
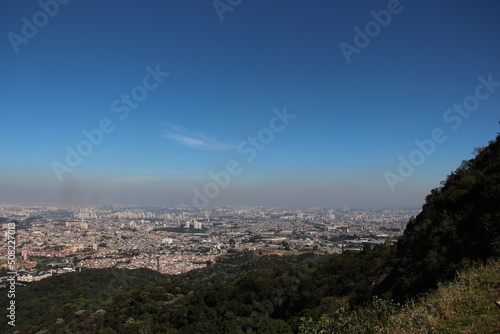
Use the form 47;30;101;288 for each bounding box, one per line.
385;260;500;334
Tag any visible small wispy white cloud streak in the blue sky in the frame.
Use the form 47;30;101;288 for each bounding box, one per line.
163;123;236;151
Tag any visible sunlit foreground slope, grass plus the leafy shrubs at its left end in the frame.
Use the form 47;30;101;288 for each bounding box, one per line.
298;260;500;334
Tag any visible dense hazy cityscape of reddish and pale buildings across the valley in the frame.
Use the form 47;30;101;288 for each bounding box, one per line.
0;204;419;282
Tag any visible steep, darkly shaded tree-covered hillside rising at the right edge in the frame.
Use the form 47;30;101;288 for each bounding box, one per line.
381;136;500;300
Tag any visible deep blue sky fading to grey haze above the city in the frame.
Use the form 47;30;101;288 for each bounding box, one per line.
0;0;500;207
